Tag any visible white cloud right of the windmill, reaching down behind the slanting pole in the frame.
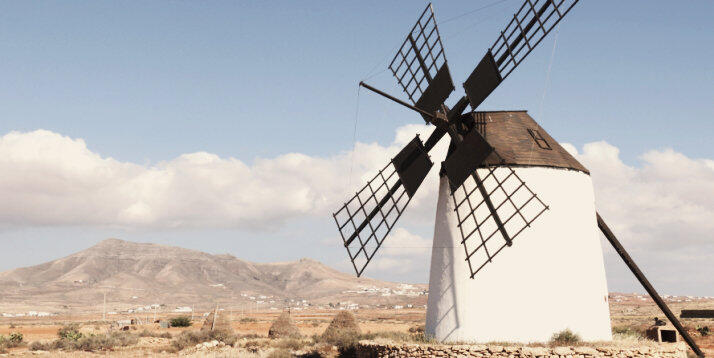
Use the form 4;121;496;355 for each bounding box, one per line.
566;142;714;294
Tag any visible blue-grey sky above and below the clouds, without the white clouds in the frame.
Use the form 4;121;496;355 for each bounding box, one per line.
0;0;714;294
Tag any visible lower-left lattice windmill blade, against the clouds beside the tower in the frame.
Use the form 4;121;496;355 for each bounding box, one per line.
332;136;434;276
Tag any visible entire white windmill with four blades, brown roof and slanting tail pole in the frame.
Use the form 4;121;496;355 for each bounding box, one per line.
333;0;701;355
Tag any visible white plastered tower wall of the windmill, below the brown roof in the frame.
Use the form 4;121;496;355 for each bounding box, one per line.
426;167;612;342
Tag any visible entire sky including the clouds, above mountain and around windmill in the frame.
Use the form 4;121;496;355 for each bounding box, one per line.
0;0;714;296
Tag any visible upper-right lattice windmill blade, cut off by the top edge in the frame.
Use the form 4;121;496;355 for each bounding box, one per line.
464;0;579;109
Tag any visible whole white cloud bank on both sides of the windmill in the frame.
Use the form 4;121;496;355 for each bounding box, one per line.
0;129;714;289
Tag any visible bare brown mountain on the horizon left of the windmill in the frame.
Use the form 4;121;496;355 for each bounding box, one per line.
0;239;426;308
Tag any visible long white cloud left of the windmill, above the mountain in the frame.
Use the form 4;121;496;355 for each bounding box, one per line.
0;125;444;229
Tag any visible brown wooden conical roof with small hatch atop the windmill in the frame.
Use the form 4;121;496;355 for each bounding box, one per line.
476;111;590;174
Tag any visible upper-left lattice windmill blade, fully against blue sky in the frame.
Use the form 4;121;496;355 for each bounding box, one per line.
389;4;454;120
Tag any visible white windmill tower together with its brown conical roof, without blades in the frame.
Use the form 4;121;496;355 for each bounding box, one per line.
425;112;612;342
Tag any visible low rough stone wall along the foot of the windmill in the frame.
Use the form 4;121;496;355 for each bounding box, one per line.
357;341;687;358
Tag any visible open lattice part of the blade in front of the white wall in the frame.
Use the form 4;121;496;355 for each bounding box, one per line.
452;166;548;278
